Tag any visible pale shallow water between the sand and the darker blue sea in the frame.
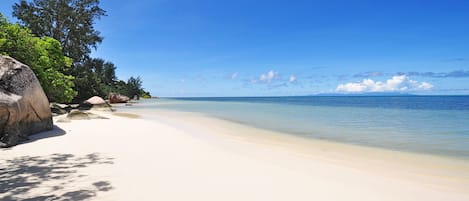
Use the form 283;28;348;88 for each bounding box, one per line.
123;98;469;160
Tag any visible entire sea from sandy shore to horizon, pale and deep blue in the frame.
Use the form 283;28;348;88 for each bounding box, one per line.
124;96;469;159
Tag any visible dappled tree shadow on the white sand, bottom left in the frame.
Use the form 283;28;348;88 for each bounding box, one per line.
0;153;114;201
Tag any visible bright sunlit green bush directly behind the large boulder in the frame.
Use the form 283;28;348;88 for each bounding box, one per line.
0;14;77;102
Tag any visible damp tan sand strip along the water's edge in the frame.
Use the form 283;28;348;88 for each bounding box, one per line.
128;109;469;190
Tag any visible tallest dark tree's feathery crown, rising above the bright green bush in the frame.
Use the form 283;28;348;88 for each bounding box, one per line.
13;0;106;62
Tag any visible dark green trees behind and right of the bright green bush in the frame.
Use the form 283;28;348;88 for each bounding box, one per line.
8;0;149;102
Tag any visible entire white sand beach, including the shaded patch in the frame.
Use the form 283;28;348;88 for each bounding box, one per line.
0;112;469;201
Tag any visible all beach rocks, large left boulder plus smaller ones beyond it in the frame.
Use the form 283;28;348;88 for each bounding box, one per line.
0;55;122;147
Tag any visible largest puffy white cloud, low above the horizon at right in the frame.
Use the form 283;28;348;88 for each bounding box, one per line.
336;75;433;93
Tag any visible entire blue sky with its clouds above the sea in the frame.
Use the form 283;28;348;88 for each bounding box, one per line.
0;0;469;97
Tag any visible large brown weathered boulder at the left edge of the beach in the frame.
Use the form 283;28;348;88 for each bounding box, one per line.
0;55;52;147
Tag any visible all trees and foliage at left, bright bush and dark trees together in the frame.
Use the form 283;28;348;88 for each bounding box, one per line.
0;0;150;102
